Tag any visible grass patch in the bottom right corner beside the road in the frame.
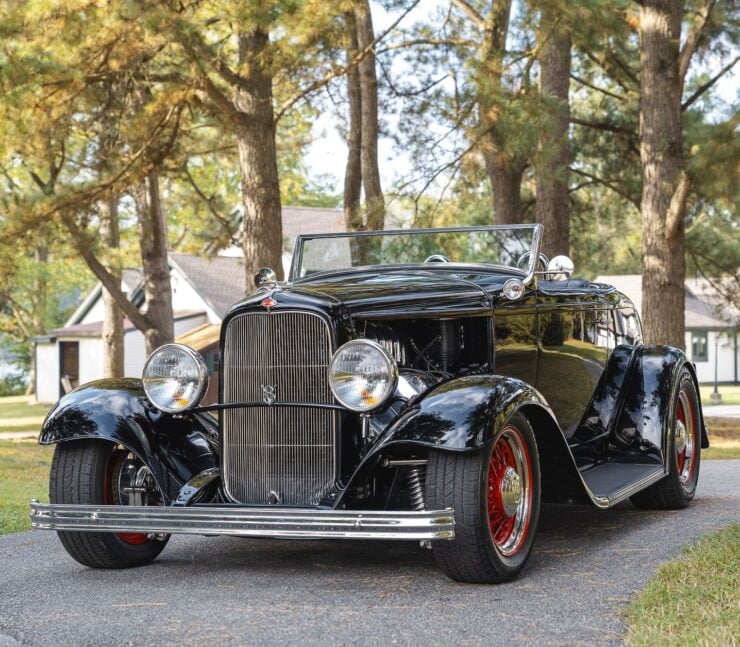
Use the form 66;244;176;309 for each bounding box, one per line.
626;523;740;647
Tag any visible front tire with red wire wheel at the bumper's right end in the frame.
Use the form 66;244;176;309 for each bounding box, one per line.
426;413;540;584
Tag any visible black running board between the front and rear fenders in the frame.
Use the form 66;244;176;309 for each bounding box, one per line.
581;463;665;508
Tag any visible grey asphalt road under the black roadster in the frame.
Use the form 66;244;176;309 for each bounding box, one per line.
0;460;740;647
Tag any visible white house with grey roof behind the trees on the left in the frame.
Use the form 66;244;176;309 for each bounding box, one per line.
34;207;344;403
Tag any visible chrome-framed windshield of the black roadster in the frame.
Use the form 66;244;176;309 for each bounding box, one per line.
291;225;542;281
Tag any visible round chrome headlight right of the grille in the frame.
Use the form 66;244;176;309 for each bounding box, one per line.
329;339;398;412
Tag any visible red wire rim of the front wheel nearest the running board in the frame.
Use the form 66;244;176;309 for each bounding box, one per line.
487;426;533;557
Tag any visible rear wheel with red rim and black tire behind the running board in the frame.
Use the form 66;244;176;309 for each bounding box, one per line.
630;368;701;510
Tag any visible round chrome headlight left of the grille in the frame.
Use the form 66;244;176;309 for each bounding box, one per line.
142;344;208;413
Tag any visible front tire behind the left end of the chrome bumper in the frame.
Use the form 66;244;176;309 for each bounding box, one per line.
49;440;169;568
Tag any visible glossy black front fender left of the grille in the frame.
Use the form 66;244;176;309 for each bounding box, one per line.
39;379;219;500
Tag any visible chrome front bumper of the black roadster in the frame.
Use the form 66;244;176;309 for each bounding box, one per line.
30;501;455;540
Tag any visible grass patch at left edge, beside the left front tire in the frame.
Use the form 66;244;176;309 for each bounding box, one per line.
0;440;54;535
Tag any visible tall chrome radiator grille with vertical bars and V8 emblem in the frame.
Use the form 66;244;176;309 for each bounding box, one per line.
222;311;339;506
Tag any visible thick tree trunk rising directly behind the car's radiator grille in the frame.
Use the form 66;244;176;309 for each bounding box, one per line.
234;28;283;292
